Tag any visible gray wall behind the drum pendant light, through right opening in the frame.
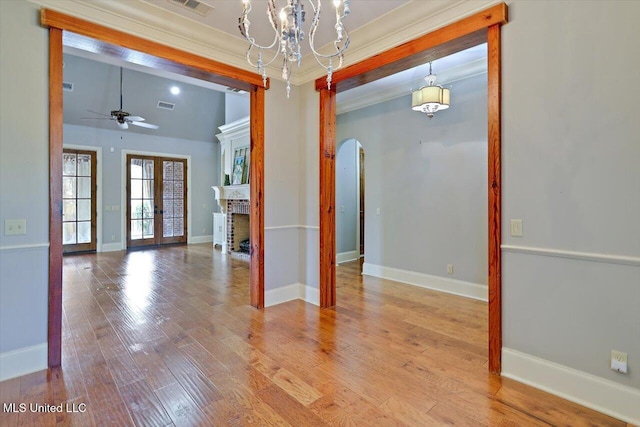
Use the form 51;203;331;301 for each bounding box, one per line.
337;74;487;285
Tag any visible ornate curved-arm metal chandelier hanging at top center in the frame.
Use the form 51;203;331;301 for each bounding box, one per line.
238;0;351;98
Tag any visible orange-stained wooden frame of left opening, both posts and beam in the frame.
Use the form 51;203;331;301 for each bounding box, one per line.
40;9;269;367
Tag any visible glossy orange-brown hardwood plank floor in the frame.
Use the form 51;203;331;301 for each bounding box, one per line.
0;244;625;426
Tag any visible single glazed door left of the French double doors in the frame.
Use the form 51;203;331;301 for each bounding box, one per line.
62;149;97;254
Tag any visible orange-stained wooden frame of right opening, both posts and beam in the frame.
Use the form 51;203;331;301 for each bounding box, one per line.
316;3;508;374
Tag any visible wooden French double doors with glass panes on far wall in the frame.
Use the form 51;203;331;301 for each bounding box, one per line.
127;154;187;247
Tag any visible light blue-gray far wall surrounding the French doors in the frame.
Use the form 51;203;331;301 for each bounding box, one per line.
64;124;220;244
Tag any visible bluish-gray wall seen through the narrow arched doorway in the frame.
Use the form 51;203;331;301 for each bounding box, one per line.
336;139;360;254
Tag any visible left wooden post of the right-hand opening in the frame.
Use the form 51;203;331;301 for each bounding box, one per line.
320;85;336;308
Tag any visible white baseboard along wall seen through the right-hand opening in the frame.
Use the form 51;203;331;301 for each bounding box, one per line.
362;262;489;301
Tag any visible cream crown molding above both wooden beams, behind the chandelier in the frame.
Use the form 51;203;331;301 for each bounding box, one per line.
28;0;500;85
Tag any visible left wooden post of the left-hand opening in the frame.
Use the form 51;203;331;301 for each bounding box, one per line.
47;28;63;368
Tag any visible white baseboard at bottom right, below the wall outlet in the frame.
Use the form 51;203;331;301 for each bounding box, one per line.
502;348;640;425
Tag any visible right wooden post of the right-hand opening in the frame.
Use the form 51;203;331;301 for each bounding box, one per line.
487;24;502;374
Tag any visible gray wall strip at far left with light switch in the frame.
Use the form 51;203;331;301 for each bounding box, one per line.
0;1;49;353
